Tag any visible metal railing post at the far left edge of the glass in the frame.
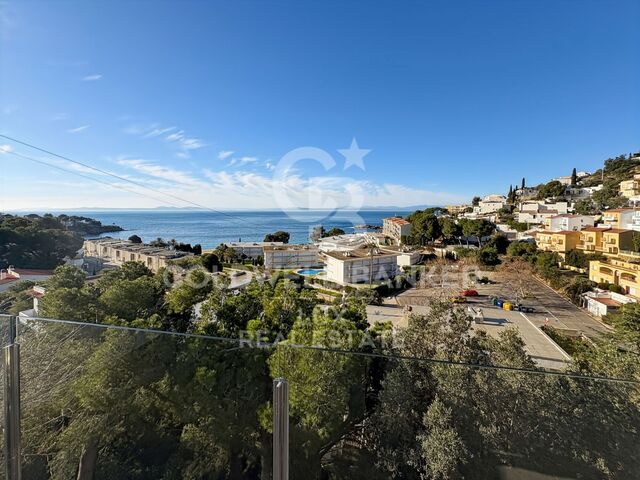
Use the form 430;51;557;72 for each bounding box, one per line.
2;317;22;480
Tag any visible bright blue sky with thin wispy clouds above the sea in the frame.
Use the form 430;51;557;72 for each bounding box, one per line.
0;0;640;209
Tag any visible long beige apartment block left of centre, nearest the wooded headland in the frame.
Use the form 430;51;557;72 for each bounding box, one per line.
83;237;192;272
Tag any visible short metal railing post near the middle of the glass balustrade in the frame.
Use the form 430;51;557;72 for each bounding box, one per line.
273;378;289;480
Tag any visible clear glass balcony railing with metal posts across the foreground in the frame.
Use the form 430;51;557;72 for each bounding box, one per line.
0;317;640;480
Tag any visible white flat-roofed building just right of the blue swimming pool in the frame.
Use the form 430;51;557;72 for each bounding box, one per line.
324;248;399;285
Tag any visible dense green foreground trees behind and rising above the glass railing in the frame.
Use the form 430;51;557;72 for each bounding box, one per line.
6;258;640;480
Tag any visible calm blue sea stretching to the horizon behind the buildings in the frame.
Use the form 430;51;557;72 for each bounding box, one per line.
56;210;409;248
